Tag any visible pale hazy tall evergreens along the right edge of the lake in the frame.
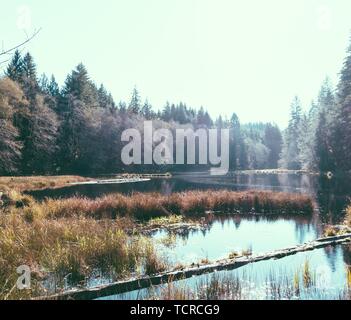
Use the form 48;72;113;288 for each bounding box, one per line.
280;35;351;172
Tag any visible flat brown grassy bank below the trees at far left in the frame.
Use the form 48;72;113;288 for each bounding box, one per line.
0;176;91;192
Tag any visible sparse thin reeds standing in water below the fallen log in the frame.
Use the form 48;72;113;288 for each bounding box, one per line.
151;261;351;300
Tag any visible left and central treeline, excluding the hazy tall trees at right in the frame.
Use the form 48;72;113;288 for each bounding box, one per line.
0;51;282;175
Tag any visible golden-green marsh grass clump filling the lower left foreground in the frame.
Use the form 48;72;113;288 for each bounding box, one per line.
0;213;166;299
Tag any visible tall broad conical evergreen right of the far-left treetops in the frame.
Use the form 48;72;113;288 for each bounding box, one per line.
58;64;100;173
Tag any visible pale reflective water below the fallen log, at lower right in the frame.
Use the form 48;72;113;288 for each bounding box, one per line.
102;246;348;300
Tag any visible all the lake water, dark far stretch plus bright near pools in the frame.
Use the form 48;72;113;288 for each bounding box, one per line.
30;173;351;299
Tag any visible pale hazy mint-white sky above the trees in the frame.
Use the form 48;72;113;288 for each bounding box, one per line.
0;0;351;126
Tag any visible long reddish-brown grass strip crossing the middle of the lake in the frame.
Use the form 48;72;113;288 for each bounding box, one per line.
15;191;314;220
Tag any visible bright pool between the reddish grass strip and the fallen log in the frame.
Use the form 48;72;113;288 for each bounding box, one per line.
153;216;322;265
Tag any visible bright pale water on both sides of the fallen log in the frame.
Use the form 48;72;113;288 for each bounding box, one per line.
99;216;351;300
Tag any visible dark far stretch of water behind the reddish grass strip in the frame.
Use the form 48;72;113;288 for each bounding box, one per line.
29;174;351;224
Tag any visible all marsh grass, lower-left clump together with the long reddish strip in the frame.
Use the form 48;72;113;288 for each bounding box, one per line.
0;189;313;299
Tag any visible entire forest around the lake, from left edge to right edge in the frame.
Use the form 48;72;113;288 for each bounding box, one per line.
0;35;351;175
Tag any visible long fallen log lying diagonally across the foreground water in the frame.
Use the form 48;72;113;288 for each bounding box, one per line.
42;233;351;300
